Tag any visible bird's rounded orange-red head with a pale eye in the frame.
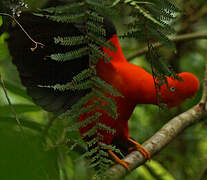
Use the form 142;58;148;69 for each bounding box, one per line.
160;72;199;108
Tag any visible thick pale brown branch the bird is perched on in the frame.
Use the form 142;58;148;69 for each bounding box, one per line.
106;61;207;180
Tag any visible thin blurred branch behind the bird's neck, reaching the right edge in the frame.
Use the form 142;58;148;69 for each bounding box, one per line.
127;32;207;61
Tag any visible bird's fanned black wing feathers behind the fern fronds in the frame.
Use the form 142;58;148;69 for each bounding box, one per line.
8;8;116;113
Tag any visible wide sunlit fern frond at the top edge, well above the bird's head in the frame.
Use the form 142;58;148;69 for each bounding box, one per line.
120;0;178;47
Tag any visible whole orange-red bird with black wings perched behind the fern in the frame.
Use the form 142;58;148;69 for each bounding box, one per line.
8;2;199;169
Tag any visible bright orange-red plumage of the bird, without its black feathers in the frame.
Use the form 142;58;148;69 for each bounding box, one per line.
80;35;199;169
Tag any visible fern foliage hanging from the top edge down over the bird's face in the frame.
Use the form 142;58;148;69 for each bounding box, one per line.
121;0;180;98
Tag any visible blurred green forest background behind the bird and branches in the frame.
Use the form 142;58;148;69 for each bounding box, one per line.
0;0;207;180
